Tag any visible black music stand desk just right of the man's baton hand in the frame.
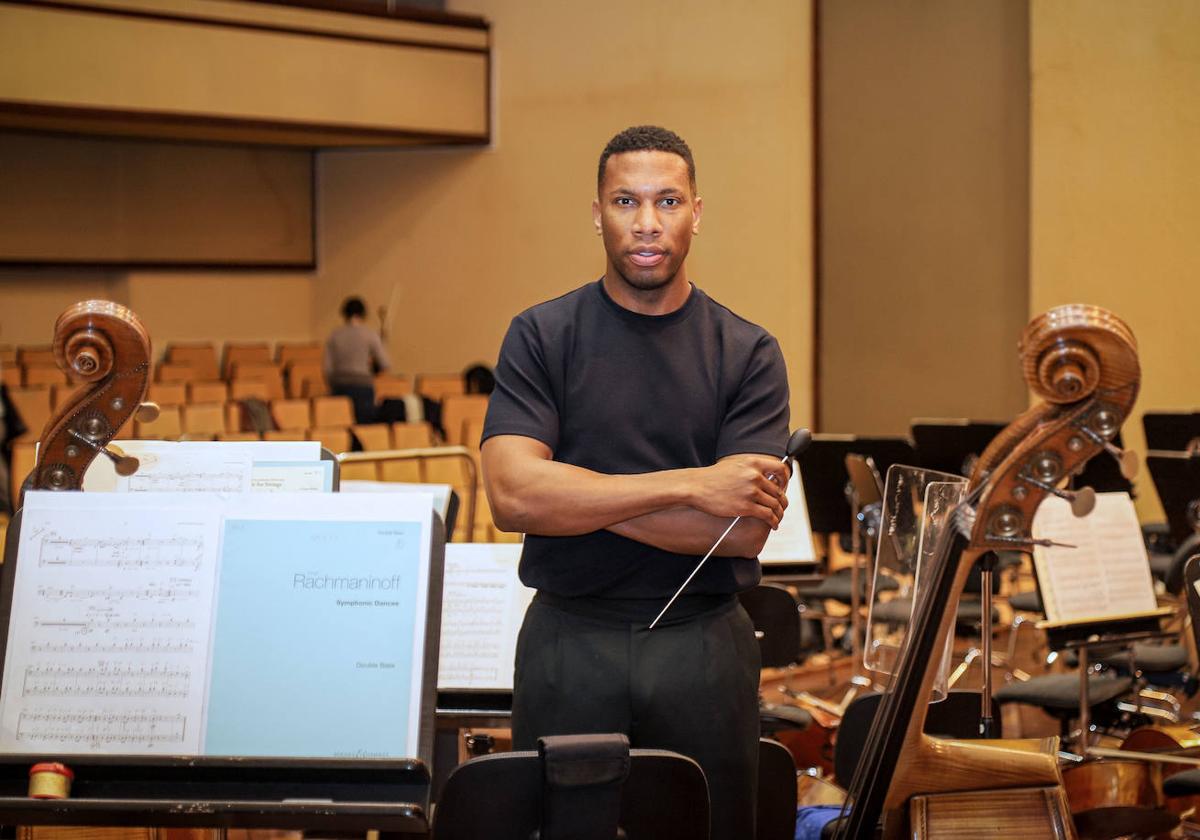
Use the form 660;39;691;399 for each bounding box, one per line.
797;434;917;534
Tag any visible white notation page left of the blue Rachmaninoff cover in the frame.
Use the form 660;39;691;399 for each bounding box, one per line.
0;493;217;755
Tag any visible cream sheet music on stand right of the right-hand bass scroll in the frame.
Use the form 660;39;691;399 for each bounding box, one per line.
1033;493;1158;622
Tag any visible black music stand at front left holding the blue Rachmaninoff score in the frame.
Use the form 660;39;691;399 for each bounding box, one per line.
0;501;445;840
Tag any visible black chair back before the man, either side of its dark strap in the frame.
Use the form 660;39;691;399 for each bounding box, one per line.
431;750;705;840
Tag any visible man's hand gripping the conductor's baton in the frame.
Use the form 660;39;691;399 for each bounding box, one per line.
689;455;791;528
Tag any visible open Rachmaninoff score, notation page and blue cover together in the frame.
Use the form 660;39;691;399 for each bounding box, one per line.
0;492;432;757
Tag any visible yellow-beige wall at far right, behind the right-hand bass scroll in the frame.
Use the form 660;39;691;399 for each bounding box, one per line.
1030;0;1200;518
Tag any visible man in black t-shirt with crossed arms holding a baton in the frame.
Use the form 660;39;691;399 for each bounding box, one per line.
482;126;788;840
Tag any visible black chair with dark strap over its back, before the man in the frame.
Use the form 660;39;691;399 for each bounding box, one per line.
431;734;705;840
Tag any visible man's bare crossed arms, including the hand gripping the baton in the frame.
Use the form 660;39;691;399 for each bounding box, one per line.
482;434;791;557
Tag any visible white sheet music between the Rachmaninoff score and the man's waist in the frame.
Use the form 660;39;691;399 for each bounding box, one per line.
438;542;534;691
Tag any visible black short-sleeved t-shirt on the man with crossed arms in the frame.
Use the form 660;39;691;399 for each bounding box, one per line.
484;281;788;600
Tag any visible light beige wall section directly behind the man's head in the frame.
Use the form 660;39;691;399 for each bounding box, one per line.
314;0;812;424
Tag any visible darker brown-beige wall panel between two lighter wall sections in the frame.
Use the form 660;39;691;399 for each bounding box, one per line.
818;0;1028;434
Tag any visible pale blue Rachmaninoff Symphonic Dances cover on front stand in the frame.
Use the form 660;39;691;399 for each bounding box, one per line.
204;520;420;757
